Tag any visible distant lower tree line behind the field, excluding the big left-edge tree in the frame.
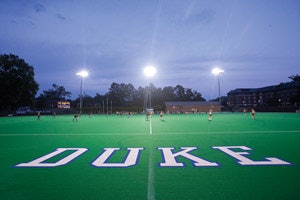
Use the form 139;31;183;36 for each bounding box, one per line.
35;82;205;112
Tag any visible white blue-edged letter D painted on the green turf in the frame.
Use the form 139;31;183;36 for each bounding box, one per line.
16;148;88;167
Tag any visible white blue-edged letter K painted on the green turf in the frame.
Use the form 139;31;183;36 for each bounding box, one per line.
158;147;219;167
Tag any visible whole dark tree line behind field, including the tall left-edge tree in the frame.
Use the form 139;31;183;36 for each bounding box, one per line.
0;54;205;114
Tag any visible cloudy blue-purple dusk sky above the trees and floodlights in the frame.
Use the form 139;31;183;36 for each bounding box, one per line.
0;0;300;100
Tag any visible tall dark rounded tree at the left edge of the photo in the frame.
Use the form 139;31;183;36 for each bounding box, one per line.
0;54;39;110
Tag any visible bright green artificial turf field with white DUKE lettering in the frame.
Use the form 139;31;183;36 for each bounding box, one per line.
0;113;300;200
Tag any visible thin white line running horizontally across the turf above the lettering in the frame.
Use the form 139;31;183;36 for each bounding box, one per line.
0;130;300;137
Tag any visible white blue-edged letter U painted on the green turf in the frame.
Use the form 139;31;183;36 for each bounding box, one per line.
92;148;144;167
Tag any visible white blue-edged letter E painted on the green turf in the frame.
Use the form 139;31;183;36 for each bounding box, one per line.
212;146;291;165
